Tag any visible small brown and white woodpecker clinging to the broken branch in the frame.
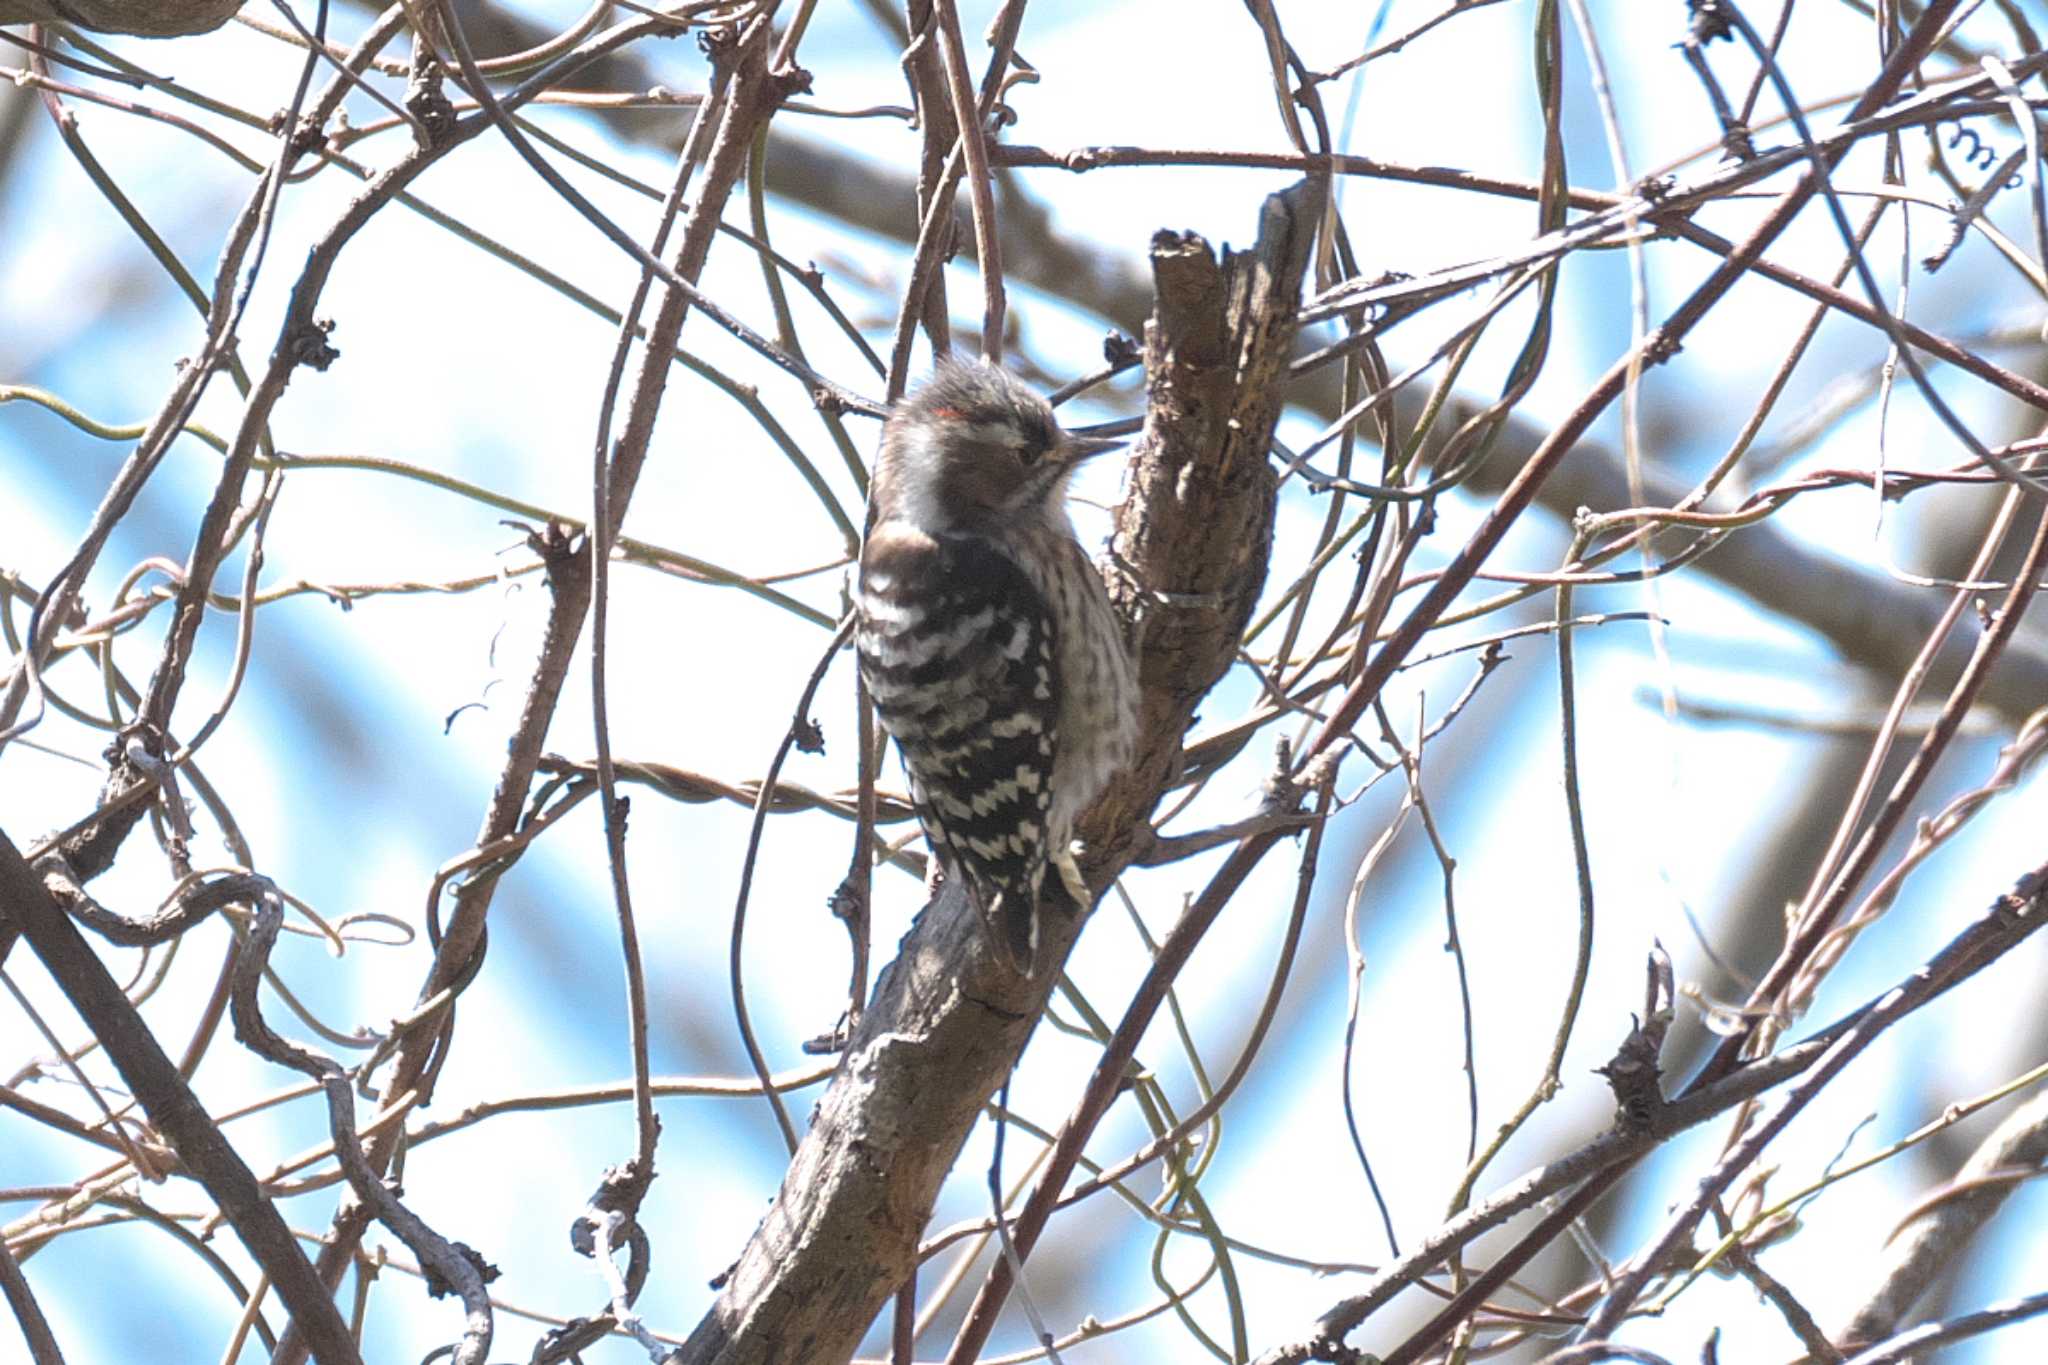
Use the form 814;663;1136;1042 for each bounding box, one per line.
854;358;1137;978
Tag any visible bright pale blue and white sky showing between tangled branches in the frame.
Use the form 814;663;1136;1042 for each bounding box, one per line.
0;0;2048;1361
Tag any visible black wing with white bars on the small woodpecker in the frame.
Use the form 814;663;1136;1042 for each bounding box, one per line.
856;522;1059;974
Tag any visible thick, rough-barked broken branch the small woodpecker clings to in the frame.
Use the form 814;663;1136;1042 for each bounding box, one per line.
674;182;1323;1365
